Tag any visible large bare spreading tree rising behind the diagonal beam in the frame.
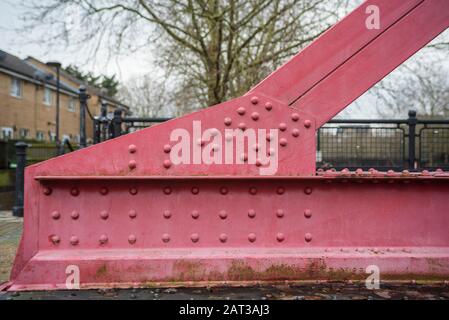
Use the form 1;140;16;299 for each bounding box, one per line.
20;0;354;111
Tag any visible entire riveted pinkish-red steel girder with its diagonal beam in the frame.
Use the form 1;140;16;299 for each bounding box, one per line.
9;0;449;290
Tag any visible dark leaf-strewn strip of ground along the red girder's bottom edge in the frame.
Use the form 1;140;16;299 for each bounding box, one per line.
0;283;449;300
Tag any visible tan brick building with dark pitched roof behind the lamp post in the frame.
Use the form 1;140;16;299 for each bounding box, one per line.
0;50;129;144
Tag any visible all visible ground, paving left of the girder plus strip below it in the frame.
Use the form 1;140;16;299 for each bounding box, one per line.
0;211;449;300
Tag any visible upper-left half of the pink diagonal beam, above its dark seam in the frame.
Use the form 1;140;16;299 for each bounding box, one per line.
248;0;424;104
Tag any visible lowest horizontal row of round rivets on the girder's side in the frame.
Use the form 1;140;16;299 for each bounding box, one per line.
51;233;312;246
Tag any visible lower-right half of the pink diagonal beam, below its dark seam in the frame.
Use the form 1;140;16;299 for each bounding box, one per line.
292;0;449;127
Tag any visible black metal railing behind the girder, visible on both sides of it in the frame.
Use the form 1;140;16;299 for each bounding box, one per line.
94;110;449;171
